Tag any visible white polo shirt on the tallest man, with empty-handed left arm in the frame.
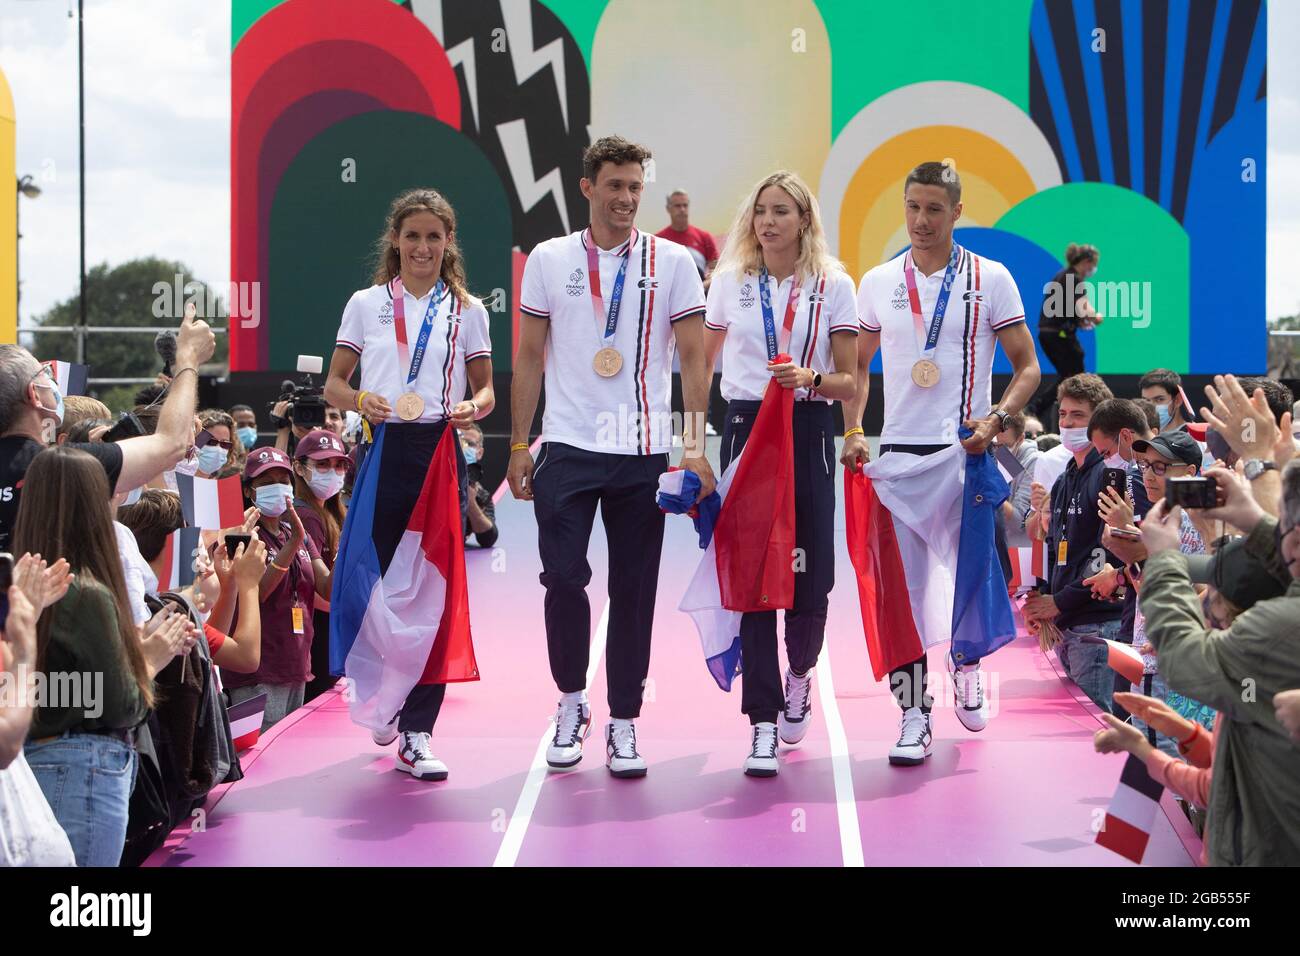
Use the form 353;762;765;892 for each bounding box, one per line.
519;230;705;455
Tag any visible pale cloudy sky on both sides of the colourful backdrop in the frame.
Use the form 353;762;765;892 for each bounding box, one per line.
0;0;1300;329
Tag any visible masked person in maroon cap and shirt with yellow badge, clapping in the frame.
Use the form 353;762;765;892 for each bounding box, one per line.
221;447;332;734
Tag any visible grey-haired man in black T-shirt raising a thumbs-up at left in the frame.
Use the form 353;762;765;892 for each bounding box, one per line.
0;307;216;550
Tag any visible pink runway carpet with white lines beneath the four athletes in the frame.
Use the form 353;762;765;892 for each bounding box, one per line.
150;455;1200;866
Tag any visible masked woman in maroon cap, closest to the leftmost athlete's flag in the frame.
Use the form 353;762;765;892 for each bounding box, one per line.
294;428;350;701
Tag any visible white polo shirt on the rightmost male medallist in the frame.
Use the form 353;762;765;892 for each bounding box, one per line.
858;248;1024;445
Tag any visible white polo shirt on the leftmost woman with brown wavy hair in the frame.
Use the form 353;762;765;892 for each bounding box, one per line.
334;282;491;421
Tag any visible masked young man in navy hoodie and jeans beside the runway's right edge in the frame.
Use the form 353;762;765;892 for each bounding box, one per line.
1024;372;1123;711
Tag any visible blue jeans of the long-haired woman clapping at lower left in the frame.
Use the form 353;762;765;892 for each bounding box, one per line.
23;734;138;866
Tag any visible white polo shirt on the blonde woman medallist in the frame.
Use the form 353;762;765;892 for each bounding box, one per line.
705;269;858;402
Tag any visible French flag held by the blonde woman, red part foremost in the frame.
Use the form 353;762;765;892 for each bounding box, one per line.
676;364;794;691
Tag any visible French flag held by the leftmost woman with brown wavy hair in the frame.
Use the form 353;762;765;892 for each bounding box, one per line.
329;425;478;730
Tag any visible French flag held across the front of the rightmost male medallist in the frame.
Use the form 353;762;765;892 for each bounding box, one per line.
844;428;1015;680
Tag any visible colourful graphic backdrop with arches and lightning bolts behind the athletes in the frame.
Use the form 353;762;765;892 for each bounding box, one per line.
231;0;1268;373
